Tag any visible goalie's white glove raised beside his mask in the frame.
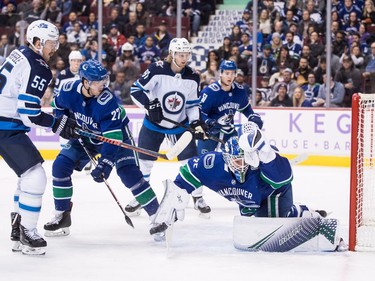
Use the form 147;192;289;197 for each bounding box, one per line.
239;122;276;167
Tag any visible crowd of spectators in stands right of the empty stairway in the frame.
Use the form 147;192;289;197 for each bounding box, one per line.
202;0;375;107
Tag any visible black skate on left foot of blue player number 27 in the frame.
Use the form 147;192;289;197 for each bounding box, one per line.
44;203;73;237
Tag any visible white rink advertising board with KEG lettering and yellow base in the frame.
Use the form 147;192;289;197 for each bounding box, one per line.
29;107;351;166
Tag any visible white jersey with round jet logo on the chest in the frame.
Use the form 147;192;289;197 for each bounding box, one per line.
131;61;199;134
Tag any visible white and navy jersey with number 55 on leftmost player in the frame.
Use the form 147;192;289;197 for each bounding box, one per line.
0;46;55;131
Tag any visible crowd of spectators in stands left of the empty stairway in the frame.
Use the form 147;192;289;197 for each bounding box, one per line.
0;0;219;105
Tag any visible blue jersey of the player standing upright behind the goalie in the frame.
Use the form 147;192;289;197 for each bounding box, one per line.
200;81;254;133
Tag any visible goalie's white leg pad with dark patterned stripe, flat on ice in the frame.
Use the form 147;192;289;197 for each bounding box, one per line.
233;216;345;252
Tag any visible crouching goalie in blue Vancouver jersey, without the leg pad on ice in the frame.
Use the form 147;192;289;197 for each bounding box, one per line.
151;122;327;232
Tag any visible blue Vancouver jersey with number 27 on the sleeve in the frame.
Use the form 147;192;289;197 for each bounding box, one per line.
53;80;129;158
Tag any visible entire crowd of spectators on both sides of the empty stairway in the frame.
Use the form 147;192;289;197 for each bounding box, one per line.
0;0;375;107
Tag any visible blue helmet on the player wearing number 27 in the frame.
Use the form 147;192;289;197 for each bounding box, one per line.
79;59;109;87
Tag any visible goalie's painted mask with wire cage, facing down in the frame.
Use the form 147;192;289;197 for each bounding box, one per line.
223;137;249;183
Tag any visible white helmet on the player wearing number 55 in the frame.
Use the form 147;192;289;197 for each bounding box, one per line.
26;20;59;50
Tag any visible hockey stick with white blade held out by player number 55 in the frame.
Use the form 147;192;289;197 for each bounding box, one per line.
75;129;193;160
